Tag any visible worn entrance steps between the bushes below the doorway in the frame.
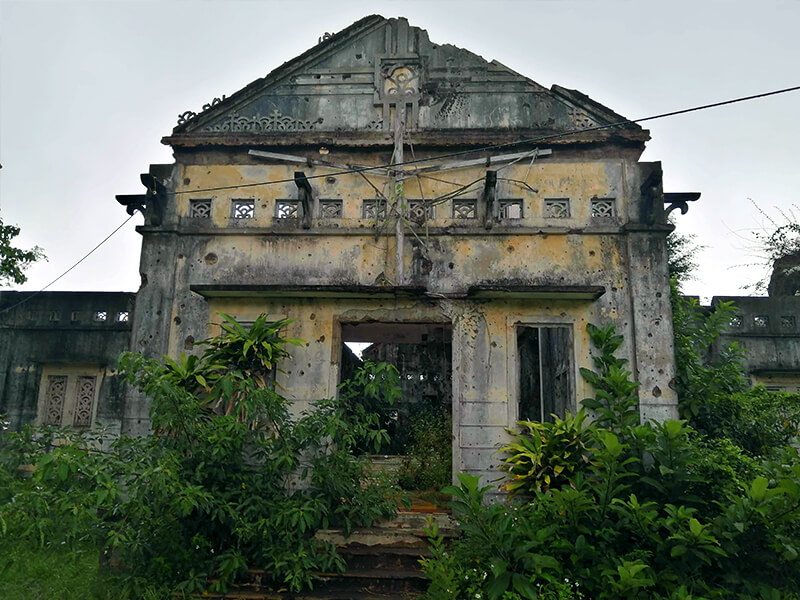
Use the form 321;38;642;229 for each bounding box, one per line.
199;511;455;600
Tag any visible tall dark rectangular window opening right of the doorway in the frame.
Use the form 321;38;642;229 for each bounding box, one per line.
517;326;574;422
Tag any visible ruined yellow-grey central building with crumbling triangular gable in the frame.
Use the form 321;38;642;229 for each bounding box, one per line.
0;16;724;482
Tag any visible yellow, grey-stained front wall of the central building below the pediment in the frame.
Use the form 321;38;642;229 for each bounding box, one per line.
128;151;676;488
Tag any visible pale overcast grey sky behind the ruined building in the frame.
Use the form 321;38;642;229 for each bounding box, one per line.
0;0;800;296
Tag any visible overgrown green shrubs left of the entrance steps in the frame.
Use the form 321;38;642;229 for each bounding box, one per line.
0;316;397;597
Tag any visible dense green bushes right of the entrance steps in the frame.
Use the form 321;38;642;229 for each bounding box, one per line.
423;324;800;600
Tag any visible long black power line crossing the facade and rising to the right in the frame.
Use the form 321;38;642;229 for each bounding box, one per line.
172;85;800;196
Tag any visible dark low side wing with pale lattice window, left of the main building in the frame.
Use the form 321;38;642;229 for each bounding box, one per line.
0;292;135;433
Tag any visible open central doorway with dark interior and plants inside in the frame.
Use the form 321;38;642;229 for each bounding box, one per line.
340;322;453;500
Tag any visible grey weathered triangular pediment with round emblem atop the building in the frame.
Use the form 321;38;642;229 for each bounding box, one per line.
165;15;646;145
